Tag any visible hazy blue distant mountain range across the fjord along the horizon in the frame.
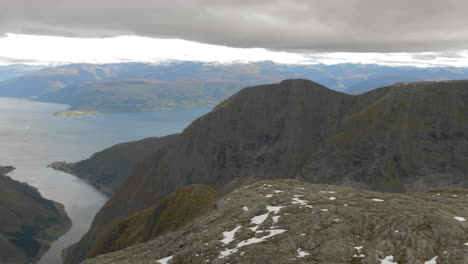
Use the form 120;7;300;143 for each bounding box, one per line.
0;61;468;116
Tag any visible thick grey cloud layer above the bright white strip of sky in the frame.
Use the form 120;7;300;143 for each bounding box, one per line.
0;0;468;52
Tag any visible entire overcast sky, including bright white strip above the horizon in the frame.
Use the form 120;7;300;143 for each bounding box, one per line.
0;0;468;66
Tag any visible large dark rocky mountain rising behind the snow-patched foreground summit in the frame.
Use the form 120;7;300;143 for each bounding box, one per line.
66;79;468;263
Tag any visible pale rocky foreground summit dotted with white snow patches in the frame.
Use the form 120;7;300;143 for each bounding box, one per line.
83;180;468;264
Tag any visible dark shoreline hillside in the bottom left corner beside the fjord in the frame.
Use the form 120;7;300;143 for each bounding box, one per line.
0;167;71;264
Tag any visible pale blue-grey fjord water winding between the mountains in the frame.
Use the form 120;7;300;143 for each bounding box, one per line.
0;98;209;264
